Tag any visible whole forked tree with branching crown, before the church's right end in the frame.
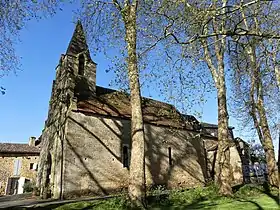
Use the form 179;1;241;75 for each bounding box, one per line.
158;0;232;195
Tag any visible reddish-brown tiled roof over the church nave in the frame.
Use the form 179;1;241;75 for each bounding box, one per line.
77;86;199;129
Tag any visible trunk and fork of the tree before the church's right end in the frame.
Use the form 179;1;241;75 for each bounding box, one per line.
201;0;232;195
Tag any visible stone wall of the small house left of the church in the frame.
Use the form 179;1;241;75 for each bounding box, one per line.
0;154;39;195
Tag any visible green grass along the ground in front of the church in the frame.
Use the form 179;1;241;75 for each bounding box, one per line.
51;185;280;210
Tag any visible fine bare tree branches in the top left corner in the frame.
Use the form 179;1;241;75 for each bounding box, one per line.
0;0;59;94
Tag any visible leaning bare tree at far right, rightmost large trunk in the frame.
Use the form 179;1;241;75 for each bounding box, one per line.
231;39;279;185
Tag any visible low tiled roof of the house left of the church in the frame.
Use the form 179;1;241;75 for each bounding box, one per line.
0;143;40;155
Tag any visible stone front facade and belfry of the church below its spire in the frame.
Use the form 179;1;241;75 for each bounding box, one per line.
37;53;96;198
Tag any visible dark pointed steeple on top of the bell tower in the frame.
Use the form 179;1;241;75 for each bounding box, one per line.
66;20;88;55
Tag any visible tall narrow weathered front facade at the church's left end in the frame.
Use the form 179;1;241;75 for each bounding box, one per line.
37;55;78;198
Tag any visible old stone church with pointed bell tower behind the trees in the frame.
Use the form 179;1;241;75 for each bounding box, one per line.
37;22;243;198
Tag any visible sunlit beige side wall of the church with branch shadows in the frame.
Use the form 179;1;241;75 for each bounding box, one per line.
60;112;206;197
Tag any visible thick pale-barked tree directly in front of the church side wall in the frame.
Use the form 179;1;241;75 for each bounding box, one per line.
81;0;145;206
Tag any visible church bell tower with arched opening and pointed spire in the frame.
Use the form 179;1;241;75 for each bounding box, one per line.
47;21;96;124
